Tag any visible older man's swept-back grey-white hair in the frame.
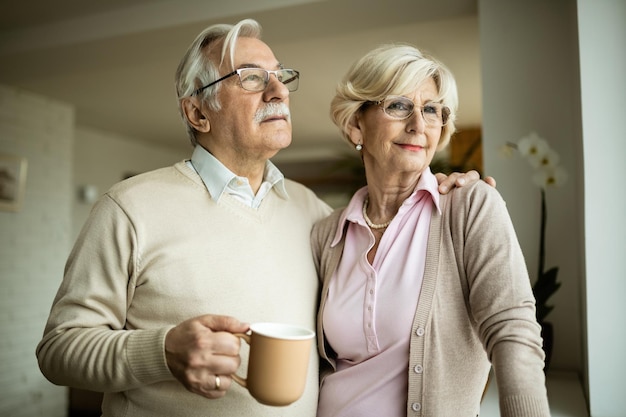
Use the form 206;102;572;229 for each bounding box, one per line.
175;19;261;146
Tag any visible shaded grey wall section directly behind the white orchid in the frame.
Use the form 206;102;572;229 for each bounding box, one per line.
479;0;583;372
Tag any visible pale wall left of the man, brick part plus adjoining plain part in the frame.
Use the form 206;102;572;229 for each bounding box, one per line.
0;85;191;417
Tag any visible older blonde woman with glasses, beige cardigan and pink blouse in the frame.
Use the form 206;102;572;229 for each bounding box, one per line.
312;45;550;417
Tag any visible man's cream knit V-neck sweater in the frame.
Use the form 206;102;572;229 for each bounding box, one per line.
37;162;330;417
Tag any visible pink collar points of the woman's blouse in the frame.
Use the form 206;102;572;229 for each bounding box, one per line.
331;167;441;246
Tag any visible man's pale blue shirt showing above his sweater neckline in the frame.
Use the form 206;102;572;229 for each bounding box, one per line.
187;145;289;208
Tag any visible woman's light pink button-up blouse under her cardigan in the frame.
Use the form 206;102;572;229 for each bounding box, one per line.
318;169;439;417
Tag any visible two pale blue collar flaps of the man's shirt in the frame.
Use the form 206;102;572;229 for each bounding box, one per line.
191;145;289;202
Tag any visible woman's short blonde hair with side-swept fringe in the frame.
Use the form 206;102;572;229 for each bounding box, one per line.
330;44;459;150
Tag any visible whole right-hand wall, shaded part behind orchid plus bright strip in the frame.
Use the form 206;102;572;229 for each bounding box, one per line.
479;0;626;417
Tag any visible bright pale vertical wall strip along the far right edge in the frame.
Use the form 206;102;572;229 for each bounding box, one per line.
577;0;626;417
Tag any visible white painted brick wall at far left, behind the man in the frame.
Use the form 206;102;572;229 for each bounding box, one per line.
0;85;74;417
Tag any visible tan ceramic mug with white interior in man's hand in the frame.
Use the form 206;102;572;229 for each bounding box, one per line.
232;323;315;406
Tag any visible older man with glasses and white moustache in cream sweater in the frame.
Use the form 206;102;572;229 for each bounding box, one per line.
37;20;486;417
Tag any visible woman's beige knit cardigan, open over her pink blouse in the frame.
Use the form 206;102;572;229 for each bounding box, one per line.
312;181;550;417
